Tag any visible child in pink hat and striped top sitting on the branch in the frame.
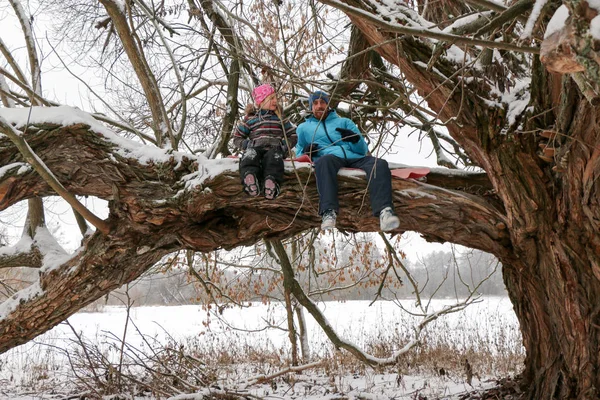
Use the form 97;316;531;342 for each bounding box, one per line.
233;84;297;200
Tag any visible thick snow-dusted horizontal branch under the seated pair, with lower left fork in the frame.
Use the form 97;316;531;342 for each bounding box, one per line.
0;119;510;352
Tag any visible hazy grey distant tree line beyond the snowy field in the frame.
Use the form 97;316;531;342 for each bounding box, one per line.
91;245;506;306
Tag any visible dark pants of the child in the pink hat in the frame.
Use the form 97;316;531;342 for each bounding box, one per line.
240;146;283;186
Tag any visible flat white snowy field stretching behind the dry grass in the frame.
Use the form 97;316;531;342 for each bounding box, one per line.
0;297;520;399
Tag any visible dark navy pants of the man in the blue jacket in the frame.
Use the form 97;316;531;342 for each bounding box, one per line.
315;154;393;217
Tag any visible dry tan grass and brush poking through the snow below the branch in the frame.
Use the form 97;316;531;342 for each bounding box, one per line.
0;304;524;399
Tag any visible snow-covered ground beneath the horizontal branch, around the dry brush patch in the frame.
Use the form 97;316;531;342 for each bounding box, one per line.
0;297;520;400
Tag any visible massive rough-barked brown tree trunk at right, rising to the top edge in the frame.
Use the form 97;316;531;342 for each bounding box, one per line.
325;1;600;399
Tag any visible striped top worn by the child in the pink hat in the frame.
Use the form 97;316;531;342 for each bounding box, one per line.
233;110;298;149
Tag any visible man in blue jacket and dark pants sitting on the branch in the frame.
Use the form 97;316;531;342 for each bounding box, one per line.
296;90;400;232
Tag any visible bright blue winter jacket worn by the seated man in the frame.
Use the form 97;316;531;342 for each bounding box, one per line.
296;110;368;160
